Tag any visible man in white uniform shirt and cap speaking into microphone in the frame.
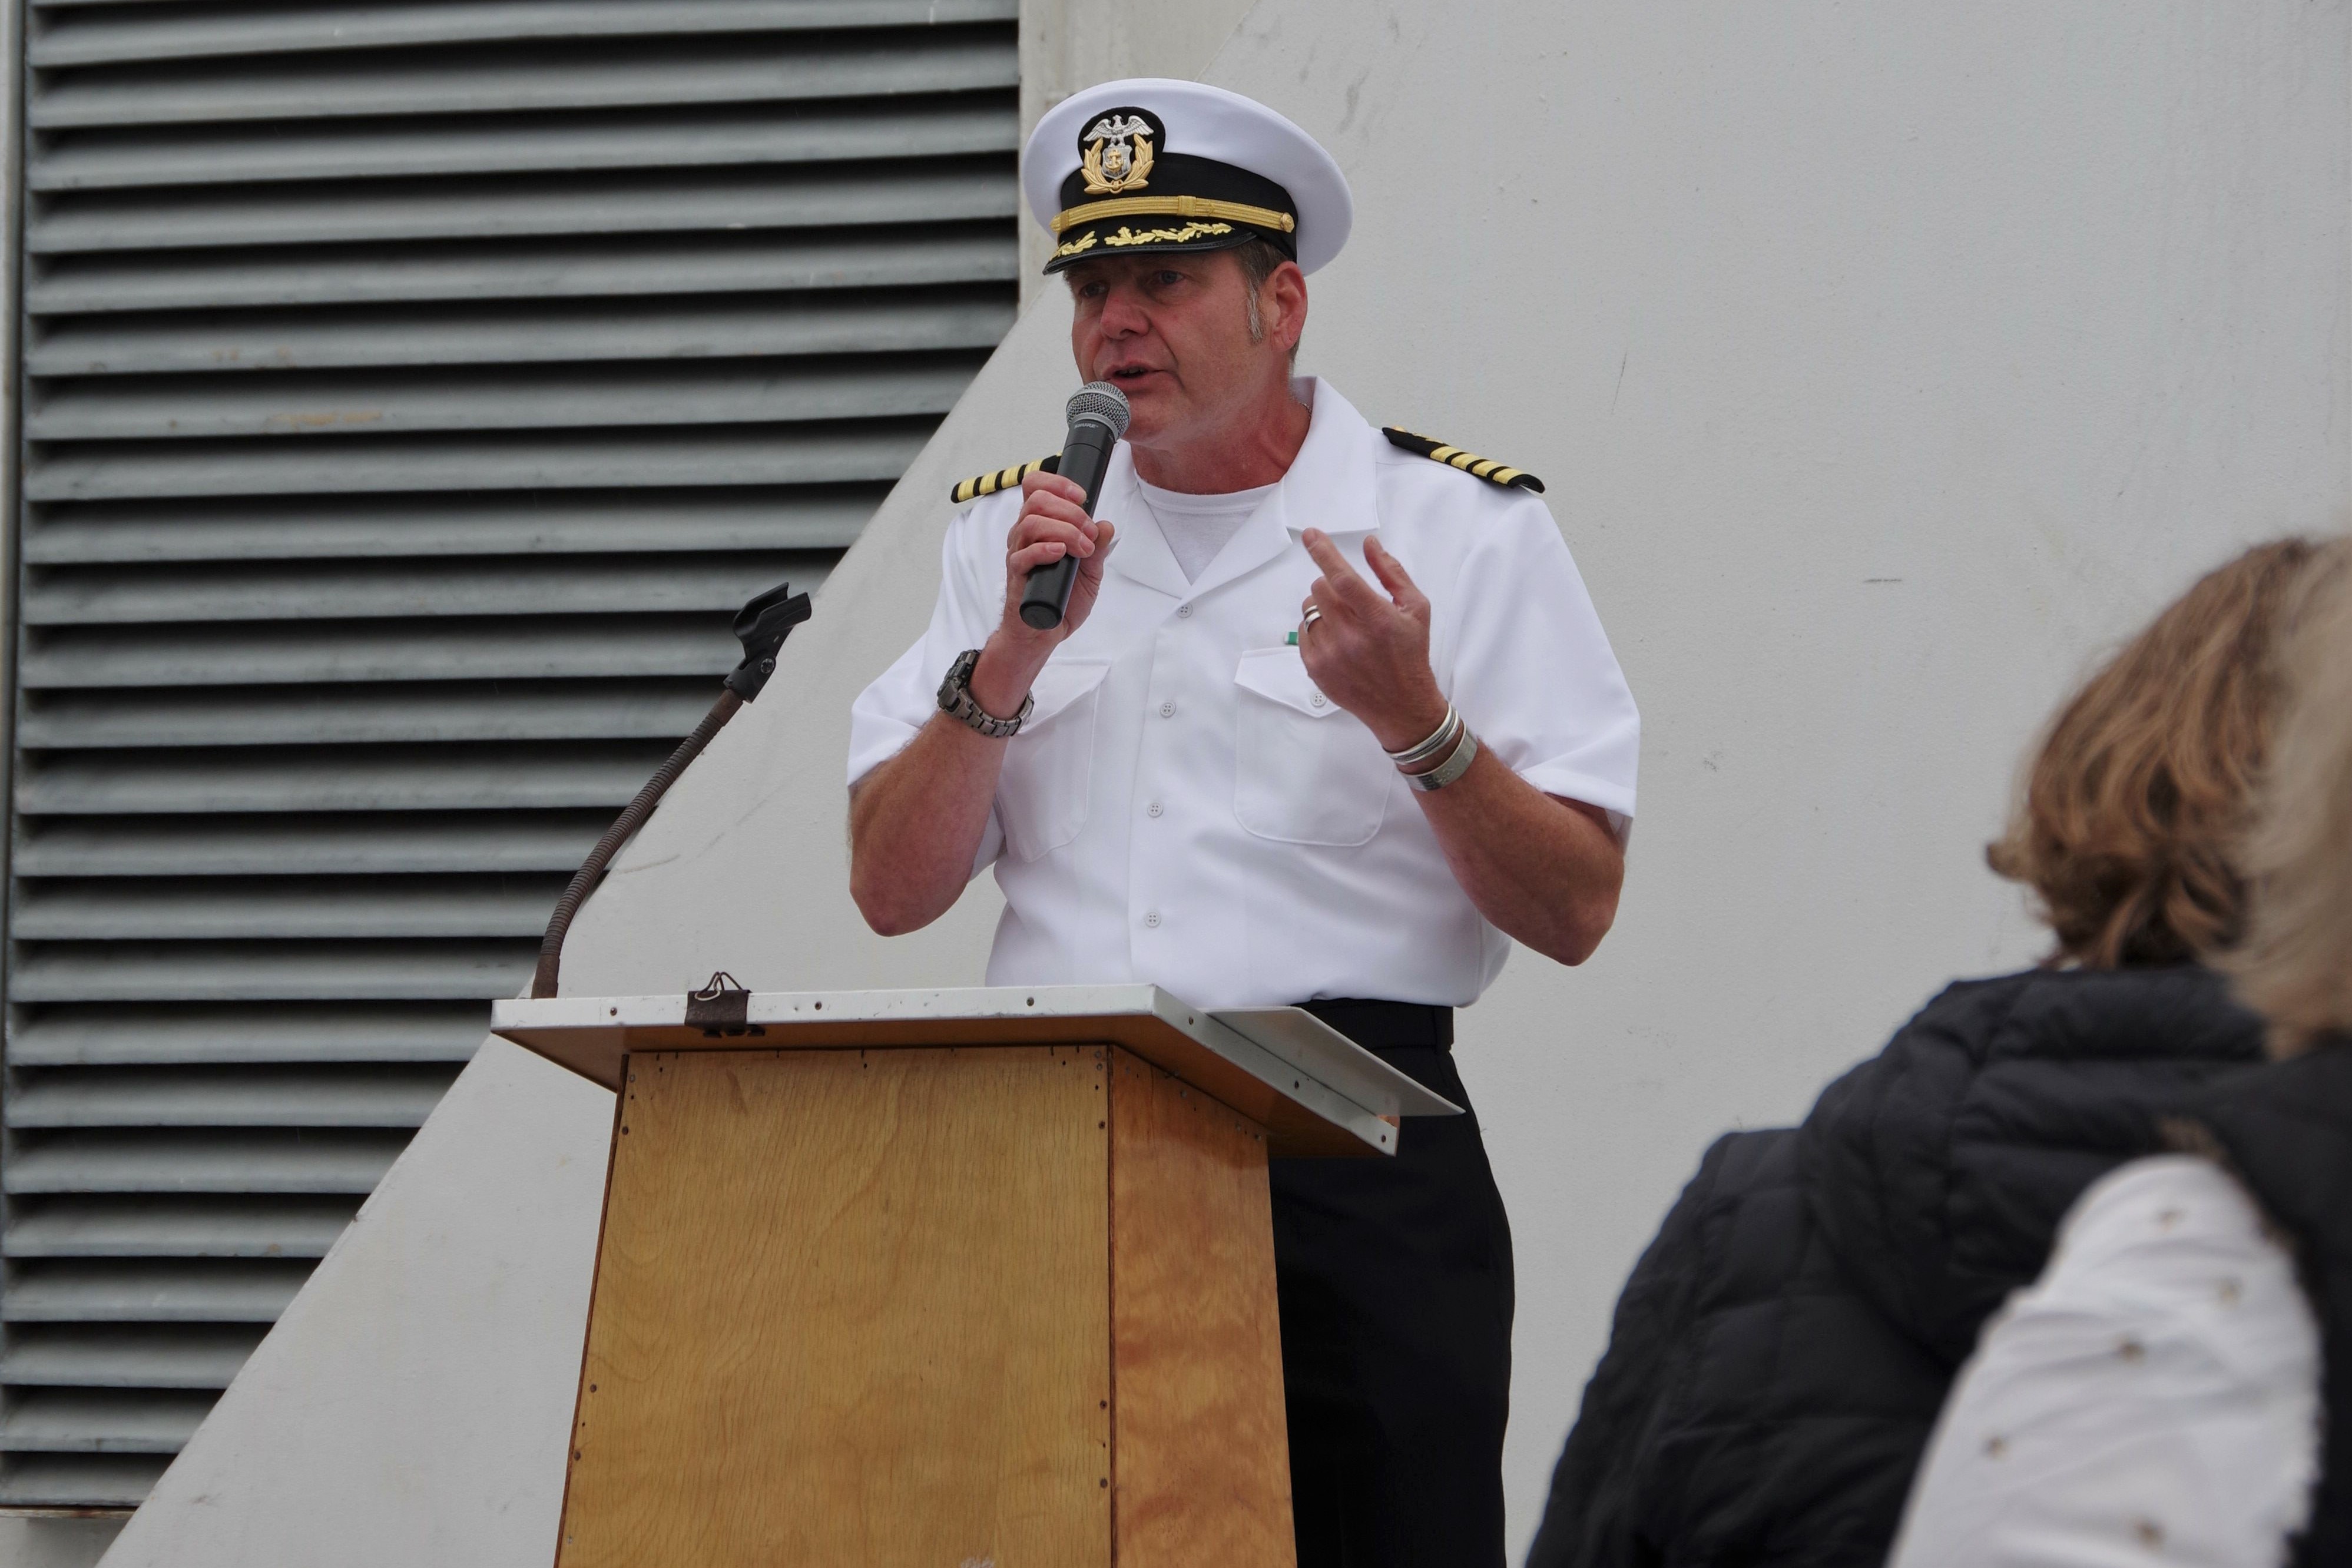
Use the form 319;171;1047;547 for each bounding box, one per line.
849;80;1639;1568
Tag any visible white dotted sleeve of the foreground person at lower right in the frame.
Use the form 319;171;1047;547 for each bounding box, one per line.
1889;1154;2319;1568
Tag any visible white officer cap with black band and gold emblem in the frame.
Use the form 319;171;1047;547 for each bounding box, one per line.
1021;78;1355;273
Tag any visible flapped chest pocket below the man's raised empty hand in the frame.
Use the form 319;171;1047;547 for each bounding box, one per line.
1233;647;1397;846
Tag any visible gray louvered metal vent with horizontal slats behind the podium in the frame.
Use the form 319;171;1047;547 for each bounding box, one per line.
0;0;1018;1504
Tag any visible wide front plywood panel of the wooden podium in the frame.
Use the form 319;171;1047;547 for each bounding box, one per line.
558;1046;1112;1568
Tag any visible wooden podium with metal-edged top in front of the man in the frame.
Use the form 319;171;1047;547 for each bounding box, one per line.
492;985;1458;1568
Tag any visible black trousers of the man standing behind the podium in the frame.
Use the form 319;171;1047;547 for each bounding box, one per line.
1270;1002;1512;1568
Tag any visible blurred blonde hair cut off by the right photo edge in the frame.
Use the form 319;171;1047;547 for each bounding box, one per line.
2225;538;2352;1056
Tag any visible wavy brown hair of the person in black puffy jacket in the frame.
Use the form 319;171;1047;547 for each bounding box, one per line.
1985;538;2321;969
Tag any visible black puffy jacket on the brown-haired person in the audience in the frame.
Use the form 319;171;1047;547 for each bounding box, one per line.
1529;969;2262;1568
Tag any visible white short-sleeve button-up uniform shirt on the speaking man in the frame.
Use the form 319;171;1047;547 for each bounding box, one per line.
849;381;1639;1009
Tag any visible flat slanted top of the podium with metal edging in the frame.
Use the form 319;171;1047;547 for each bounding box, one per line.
489;985;1460;1154
